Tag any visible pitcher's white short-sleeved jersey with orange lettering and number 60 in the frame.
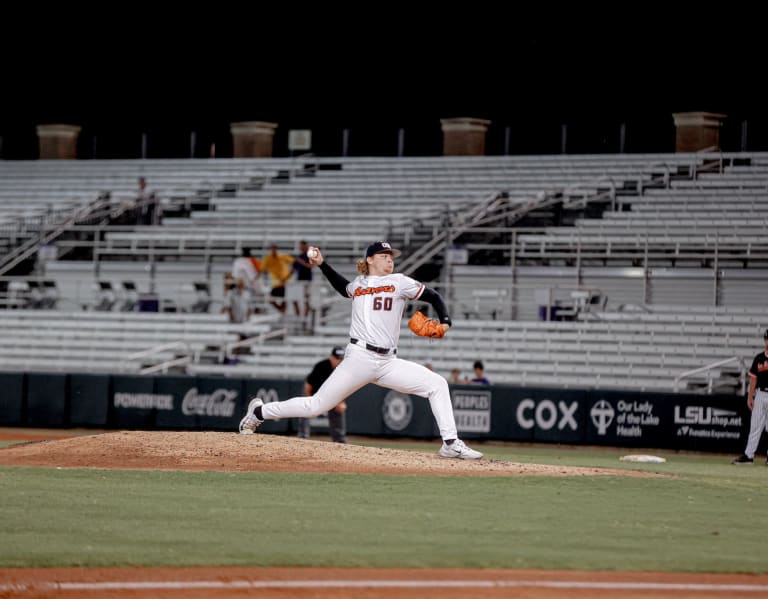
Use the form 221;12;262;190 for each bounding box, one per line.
347;273;424;348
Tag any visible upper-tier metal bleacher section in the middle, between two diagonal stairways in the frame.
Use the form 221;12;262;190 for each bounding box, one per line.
85;155;708;257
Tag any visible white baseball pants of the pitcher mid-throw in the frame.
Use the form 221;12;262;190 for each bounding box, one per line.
261;343;458;439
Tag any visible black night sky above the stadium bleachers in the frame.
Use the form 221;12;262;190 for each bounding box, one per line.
0;5;768;157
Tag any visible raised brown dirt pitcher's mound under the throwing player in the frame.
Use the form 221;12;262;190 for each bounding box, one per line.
0;431;655;476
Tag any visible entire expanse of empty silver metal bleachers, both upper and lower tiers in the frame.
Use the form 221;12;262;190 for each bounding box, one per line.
0;154;768;391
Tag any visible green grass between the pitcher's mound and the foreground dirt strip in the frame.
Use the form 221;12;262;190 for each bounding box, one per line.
0;440;768;573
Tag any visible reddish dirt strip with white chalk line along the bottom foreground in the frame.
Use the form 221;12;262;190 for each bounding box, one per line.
0;568;768;599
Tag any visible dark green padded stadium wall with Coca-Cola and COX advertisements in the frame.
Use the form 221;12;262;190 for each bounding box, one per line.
0;373;750;452
